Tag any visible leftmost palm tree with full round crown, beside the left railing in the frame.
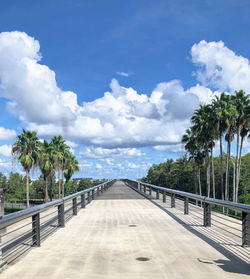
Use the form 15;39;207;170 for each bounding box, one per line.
12;129;41;207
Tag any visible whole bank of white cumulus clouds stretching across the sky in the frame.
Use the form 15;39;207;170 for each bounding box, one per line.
0;31;250;155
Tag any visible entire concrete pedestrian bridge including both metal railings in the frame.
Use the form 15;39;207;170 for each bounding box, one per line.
0;180;250;279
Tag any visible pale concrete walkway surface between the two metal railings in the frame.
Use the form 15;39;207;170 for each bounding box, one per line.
1;182;249;279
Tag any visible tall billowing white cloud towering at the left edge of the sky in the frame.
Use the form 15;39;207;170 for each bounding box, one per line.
0;31;74;125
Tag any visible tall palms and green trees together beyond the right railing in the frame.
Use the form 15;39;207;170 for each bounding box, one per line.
142;90;250;205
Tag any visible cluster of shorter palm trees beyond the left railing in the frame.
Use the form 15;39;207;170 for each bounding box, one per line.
12;129;80;207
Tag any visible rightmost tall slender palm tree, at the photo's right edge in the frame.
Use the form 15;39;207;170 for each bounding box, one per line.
232;90;250;202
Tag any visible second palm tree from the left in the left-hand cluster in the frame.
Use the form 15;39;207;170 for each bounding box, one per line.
39;140;54;202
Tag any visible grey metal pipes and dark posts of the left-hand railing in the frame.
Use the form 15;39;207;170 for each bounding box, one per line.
0;180;115;268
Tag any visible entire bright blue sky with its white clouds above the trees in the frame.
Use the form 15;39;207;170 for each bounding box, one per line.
0;0;250;178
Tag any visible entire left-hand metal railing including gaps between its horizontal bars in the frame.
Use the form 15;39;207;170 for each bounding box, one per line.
0;180;115;268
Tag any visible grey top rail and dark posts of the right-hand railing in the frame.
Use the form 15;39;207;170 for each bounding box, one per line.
123;179;250;247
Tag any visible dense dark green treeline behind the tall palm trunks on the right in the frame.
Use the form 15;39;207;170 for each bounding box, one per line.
142;153;250;204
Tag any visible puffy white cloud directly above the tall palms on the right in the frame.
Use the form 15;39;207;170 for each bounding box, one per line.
191;41;250;92
